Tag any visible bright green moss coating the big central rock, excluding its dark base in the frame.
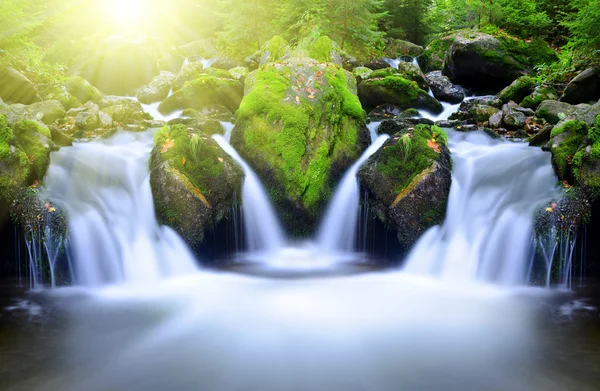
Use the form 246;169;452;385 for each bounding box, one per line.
237;64;365;213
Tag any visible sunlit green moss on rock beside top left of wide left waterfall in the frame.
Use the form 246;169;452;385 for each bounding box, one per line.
13;120;52;179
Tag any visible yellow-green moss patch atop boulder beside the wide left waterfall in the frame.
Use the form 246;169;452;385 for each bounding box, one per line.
154;125;226;197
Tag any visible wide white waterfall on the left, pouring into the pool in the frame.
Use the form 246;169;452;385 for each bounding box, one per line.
43;132;196;285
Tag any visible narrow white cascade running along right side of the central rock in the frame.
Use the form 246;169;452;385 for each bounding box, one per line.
317;133;390;253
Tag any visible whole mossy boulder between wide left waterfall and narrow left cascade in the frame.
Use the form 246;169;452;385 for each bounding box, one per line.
150;125;243;251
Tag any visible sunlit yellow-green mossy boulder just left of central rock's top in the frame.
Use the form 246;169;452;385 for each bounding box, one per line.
158;75;244;114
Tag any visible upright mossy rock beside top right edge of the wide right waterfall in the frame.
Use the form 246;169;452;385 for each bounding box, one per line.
549;120;587;183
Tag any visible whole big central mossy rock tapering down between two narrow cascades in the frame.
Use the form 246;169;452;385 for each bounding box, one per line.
232;59;368;235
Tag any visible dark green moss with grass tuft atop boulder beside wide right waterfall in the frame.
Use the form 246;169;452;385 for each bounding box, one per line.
377;124;447;194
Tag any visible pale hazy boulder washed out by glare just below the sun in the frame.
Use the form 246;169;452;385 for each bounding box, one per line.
74;35;158;95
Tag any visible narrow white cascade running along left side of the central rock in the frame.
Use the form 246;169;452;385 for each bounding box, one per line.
213;132;286;254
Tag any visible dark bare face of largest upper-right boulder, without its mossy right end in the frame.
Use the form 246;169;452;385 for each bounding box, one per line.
443;32;527;91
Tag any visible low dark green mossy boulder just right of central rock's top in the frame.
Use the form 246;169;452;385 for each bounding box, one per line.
358;68;443;113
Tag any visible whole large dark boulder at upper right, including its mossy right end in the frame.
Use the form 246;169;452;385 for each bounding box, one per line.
443;30;556;91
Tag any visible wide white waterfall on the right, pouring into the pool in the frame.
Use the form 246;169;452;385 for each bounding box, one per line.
405;131;559;285
